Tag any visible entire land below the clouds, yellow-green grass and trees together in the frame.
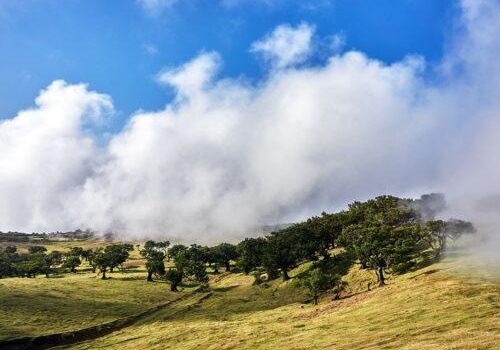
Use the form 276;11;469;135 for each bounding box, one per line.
0;196;500;350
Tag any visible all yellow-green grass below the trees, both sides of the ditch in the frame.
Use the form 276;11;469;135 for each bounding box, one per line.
0;237;500;350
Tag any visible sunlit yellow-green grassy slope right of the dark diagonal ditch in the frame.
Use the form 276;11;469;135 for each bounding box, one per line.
56;261;500;350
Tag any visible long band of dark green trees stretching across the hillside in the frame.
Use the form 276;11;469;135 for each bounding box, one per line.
0;194;474;301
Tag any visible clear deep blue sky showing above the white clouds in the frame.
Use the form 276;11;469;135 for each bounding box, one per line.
0;0;457;129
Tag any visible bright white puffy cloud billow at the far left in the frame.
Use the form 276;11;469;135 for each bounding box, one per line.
0;81;112;231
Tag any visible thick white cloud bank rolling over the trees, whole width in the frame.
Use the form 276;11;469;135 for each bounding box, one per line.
0;1;500;241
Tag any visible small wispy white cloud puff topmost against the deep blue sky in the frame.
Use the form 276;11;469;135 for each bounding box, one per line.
251;23;314;69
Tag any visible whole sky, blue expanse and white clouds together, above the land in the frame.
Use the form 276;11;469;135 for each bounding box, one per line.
4;0;500;242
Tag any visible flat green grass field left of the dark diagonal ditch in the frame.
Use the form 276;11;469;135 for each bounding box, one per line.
0;249;189;340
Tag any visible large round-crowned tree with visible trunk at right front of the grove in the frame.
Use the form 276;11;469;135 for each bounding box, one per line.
342;196;425;285
